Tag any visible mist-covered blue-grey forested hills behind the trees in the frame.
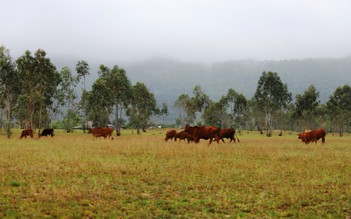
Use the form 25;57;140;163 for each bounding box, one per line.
53;56;351;122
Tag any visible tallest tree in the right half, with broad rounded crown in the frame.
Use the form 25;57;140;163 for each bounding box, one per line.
254;71;291;136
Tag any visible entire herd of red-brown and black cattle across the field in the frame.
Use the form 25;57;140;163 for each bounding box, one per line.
20;125;326;144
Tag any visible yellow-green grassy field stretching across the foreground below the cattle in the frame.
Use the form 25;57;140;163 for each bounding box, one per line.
0;130;351;218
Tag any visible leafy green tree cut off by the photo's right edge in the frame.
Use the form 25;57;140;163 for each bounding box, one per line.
327;85;351;136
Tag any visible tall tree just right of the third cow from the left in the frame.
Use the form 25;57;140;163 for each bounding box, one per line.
98;65;132;136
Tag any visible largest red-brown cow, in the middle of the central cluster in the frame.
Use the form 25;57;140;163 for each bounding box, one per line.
184;125;219;144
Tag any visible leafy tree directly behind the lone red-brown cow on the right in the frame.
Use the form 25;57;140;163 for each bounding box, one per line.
294;85;320;128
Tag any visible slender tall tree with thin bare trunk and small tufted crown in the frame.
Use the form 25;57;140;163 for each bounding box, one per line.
76;60;90;132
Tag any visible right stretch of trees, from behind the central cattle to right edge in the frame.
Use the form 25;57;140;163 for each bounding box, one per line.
174;71;351;136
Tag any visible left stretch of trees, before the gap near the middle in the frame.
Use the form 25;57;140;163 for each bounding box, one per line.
0;46;168;138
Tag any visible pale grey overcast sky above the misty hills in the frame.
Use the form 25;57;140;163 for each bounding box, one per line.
0;0;351;62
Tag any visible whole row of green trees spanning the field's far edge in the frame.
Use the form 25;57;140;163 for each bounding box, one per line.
0;46;351;138
